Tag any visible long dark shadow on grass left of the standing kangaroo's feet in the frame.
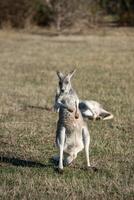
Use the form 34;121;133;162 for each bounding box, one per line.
0;156;53;168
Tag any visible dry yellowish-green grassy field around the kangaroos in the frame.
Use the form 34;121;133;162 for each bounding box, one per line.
0;29;134;200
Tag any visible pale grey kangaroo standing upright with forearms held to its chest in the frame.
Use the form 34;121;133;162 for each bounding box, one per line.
53;71;90;171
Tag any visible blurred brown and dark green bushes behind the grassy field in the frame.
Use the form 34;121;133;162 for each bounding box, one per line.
0;0;134;31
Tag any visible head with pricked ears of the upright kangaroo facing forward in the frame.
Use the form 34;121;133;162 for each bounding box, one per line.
57;70;76;93
